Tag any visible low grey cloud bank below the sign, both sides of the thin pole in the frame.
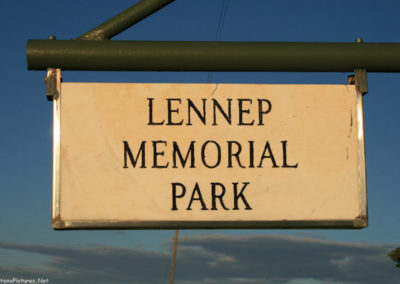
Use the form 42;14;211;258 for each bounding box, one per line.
0;235;400;284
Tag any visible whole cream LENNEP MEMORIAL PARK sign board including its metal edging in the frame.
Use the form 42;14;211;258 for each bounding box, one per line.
53;83;367;229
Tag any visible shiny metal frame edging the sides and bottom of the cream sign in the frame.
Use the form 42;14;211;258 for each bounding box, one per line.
52;79;368;230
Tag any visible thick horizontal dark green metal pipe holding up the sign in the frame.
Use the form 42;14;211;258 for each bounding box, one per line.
26;40;400;72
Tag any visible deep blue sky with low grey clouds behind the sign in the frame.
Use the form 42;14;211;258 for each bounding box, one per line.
0;0;400;283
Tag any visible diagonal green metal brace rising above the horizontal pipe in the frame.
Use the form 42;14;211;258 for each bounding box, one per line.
78;0;175;40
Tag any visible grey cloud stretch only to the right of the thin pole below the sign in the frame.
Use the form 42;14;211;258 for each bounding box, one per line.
178;236;400;283
